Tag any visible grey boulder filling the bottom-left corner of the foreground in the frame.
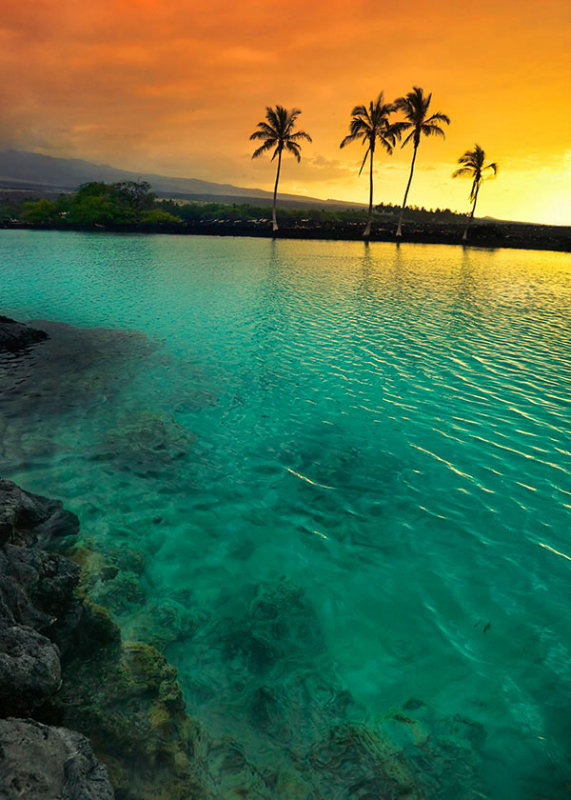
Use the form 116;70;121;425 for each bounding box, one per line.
0;719;114;800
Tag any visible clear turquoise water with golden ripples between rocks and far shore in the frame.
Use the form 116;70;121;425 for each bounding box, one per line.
0;231;571;800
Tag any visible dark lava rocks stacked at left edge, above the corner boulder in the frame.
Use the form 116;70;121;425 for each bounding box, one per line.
0;481;79;716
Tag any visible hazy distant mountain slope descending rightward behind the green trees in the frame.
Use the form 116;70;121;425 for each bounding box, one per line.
0;150;361;208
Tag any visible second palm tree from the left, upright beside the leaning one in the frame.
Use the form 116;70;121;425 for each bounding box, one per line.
339;92;399;237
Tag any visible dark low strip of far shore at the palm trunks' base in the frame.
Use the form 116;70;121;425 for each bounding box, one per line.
0;220;571;253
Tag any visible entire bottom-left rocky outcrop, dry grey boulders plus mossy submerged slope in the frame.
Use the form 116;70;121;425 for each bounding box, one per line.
0;481;202;800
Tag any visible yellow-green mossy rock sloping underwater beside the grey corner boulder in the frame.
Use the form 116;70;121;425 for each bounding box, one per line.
53;642;204;800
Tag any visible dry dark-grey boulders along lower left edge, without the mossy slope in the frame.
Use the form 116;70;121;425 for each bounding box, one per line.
0;481;113;800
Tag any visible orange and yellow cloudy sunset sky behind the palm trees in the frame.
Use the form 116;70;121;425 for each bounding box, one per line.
0;0;571;224
